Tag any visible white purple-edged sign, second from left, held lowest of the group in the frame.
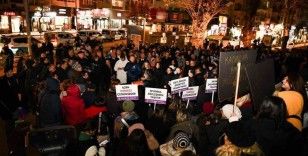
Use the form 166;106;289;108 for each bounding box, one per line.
144;88;168;104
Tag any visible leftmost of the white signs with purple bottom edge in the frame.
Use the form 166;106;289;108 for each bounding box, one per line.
116;85;139;101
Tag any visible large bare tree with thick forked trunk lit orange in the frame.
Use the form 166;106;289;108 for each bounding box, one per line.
163;0;232;46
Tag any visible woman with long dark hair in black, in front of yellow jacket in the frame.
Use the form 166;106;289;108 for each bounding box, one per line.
255;96;302;155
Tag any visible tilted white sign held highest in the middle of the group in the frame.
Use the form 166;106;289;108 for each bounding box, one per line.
170;77;189;94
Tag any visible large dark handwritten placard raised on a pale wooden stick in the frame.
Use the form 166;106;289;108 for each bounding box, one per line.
218;50;257;101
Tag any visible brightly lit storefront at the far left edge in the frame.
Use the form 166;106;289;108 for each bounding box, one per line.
0;11;24;33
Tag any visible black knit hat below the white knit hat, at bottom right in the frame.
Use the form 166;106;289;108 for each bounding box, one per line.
225;121;256;147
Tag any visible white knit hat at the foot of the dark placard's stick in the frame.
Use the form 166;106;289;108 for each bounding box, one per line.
221;104;242;123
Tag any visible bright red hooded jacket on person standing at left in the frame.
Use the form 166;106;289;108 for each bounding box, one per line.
62;84;85;125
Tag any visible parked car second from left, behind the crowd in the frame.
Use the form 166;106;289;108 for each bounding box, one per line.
44;32;75;46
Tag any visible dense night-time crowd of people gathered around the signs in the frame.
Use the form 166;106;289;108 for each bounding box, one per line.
0;35;308;156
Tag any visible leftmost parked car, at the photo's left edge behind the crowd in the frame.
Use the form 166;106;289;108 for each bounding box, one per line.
0;35;42;55
